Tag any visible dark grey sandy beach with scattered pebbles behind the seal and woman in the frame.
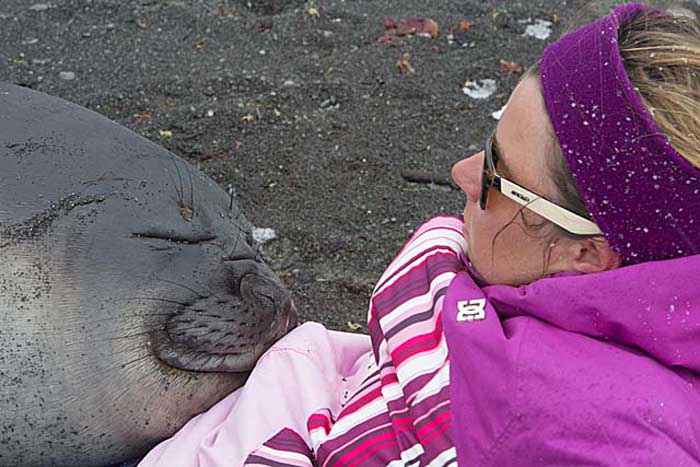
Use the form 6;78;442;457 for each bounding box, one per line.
0;0;699;332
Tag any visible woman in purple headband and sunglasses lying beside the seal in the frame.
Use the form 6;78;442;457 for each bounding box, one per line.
142;4;700;466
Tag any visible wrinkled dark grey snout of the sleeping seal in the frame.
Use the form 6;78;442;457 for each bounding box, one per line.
156;260;297;372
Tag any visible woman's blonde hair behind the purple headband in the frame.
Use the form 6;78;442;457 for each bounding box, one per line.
618;12;700;168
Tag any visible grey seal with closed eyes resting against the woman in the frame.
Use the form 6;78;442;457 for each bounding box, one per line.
0;83;296;466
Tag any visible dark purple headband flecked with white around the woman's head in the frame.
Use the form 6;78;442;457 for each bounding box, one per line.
541;4;700;265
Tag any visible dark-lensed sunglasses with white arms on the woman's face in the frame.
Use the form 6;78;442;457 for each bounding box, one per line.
479;130;603;236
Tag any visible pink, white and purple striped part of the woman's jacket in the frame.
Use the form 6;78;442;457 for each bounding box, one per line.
244;216;465;467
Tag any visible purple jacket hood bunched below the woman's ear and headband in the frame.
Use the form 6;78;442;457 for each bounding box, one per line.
483;255;700;374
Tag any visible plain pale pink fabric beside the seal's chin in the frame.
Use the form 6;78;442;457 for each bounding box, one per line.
139;323;373;467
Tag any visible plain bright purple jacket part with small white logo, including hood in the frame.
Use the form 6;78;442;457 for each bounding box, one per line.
443;255;700;467
